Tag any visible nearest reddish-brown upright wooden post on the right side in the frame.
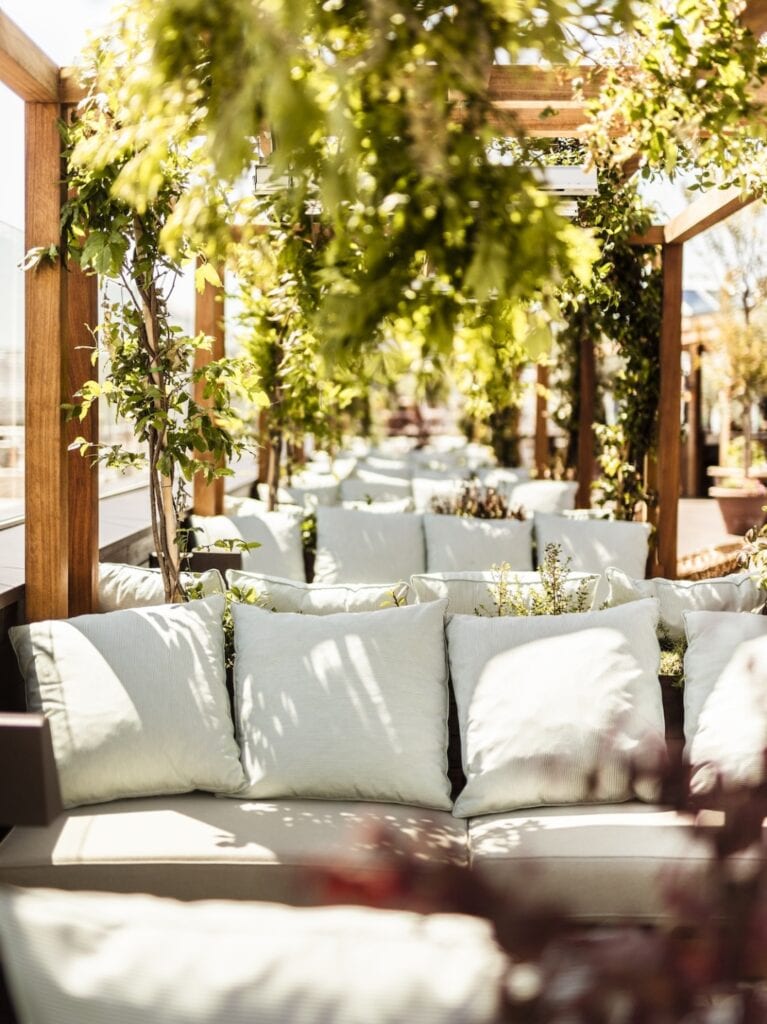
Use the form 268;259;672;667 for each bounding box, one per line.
653;239;683;580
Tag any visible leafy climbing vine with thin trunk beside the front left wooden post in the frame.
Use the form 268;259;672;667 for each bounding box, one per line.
63;13;258;601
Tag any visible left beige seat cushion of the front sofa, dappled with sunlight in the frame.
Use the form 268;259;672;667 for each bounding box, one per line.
0;794;467;905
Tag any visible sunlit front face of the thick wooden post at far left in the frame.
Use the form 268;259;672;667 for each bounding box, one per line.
25;102;70;622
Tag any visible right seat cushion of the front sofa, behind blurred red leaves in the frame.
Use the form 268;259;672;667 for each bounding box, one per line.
469;803;741;923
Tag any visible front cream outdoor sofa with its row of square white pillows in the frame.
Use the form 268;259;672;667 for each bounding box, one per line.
0;570;767;923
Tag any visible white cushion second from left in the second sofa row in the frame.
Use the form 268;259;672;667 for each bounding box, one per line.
314;508;426;583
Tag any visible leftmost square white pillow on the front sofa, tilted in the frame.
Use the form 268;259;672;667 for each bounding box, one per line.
9;596;243;807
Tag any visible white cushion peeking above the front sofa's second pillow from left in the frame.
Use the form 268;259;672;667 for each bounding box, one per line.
226;569;410;615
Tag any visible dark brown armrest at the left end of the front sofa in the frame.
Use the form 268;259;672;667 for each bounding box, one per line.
0;712;62;825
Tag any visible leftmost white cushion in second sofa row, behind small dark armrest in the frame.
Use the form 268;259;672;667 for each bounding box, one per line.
190;509;306;580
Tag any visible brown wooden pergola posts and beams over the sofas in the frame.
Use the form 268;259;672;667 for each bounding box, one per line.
0;6;767;622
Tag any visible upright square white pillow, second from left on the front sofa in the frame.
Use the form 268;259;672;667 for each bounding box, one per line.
232;601;451;810
